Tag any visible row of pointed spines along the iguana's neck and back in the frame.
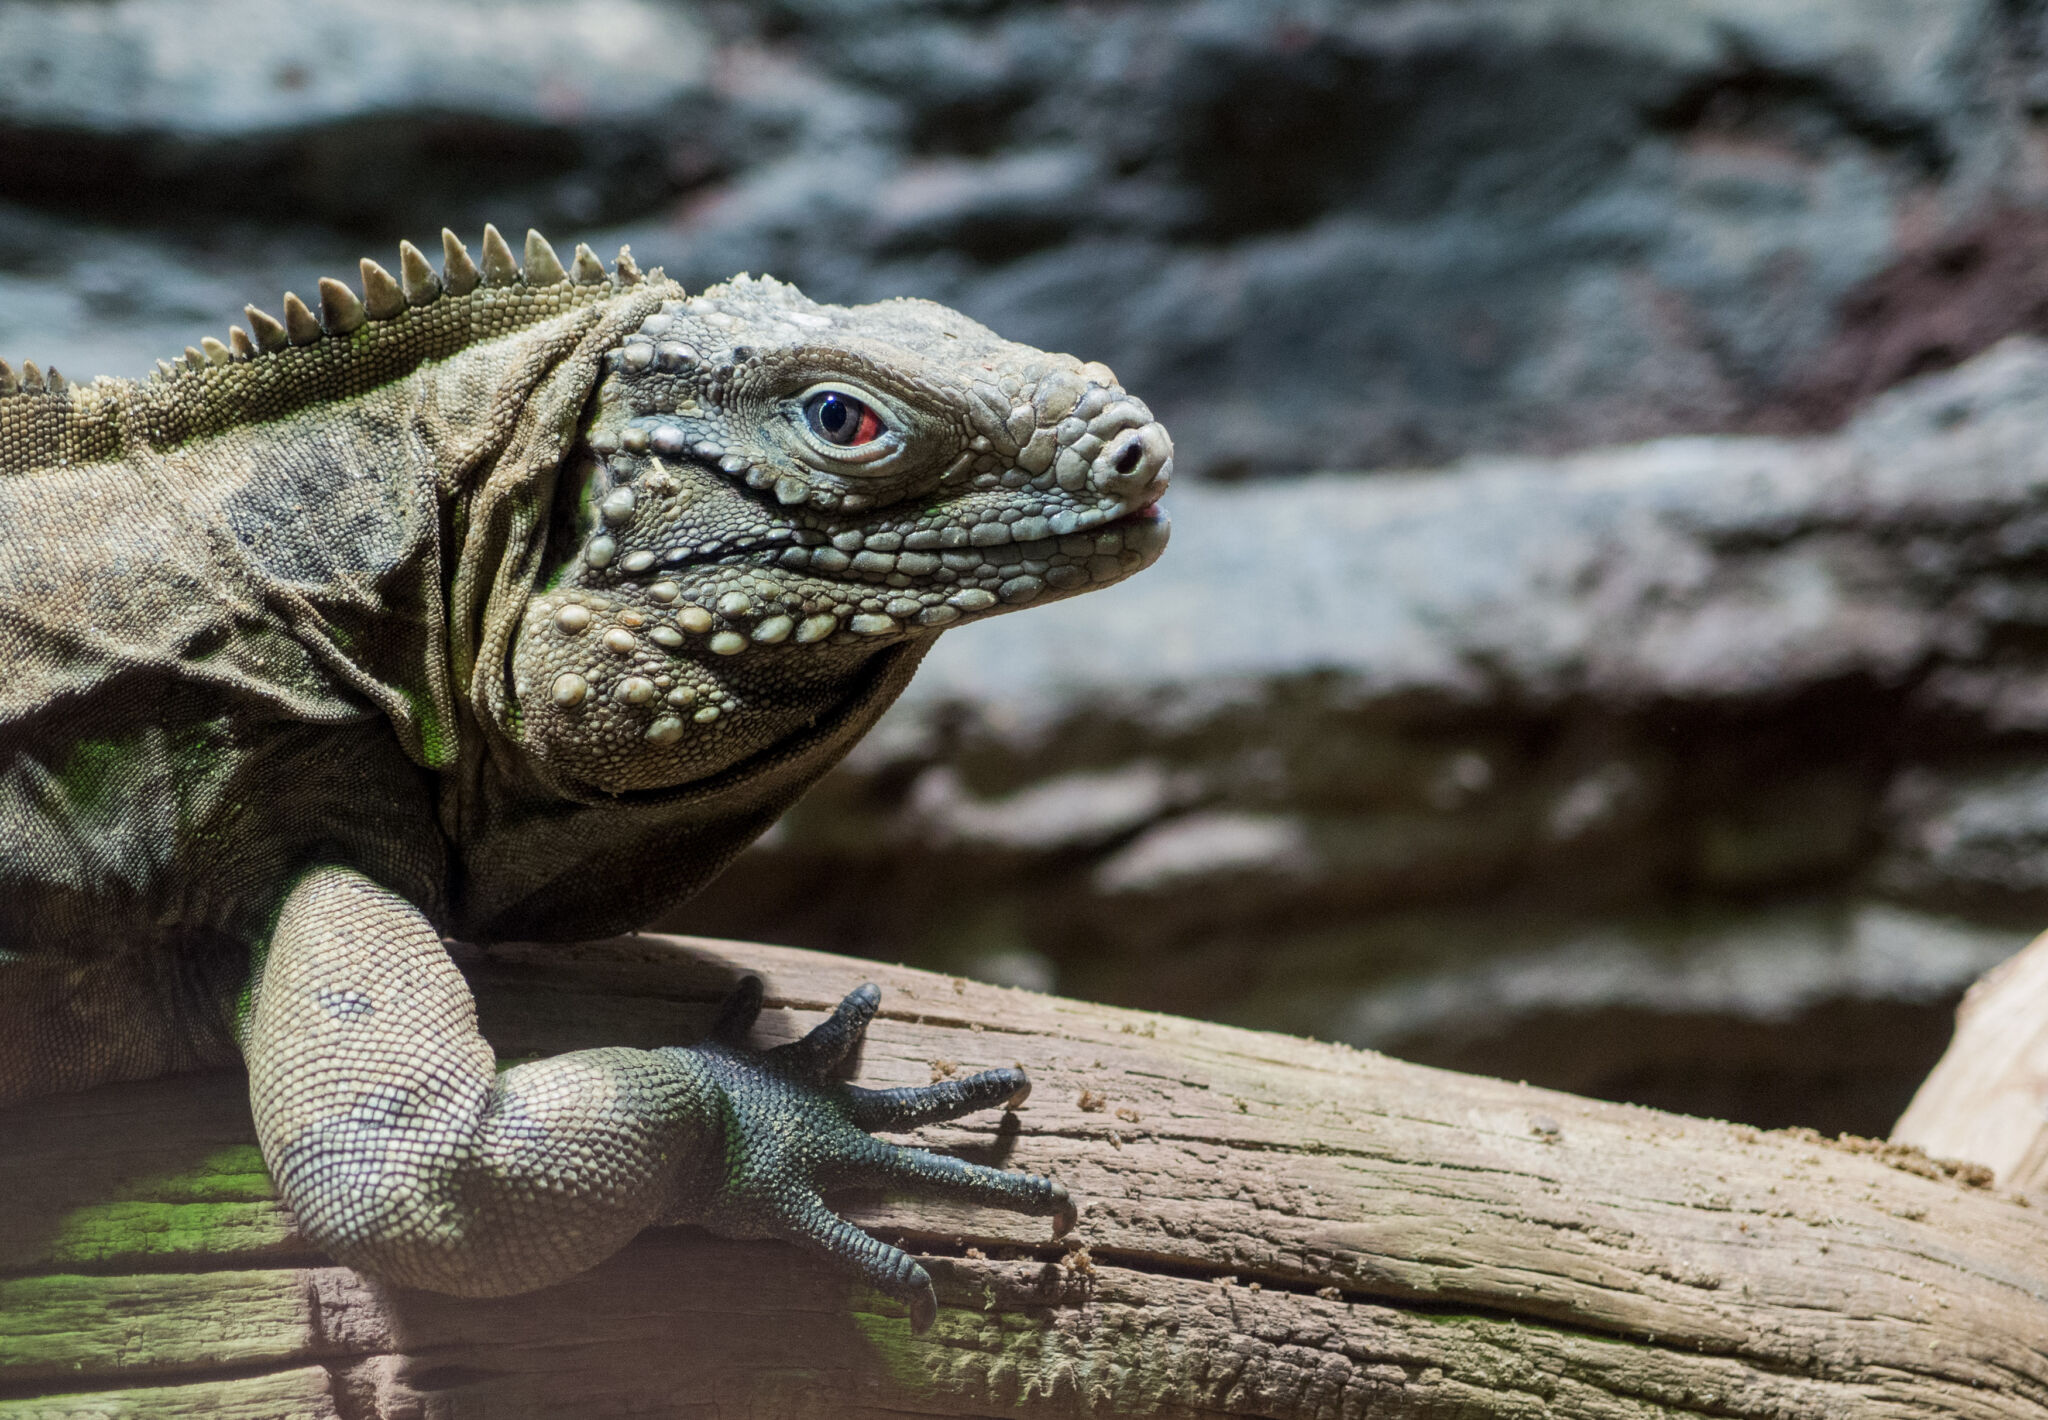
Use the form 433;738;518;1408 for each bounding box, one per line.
0;225;662;471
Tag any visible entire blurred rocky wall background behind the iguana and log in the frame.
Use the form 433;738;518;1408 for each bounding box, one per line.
12;0;2048;1133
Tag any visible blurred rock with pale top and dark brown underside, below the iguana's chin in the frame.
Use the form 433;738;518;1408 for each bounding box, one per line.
678;338;2048;1131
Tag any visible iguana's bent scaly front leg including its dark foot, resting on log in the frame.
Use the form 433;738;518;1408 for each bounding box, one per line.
242;869;1073;1330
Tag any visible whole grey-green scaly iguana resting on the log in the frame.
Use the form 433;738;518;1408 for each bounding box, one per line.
0;227;1174;1330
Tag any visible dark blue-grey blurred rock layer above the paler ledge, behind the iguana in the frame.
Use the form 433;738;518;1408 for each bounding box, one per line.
12;0;2048;475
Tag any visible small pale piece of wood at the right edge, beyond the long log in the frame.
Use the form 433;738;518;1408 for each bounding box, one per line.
1892;934;2048;1195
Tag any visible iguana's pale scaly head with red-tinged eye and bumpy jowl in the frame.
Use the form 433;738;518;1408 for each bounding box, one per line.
512;277;1174;793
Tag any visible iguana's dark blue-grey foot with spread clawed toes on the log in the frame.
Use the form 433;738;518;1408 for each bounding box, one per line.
678;975;1077;1332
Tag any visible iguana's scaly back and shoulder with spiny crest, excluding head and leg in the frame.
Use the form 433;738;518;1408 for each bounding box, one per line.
0;234;663;1084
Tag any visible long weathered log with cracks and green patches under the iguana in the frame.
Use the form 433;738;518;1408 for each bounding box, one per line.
0;936;2048;1420
